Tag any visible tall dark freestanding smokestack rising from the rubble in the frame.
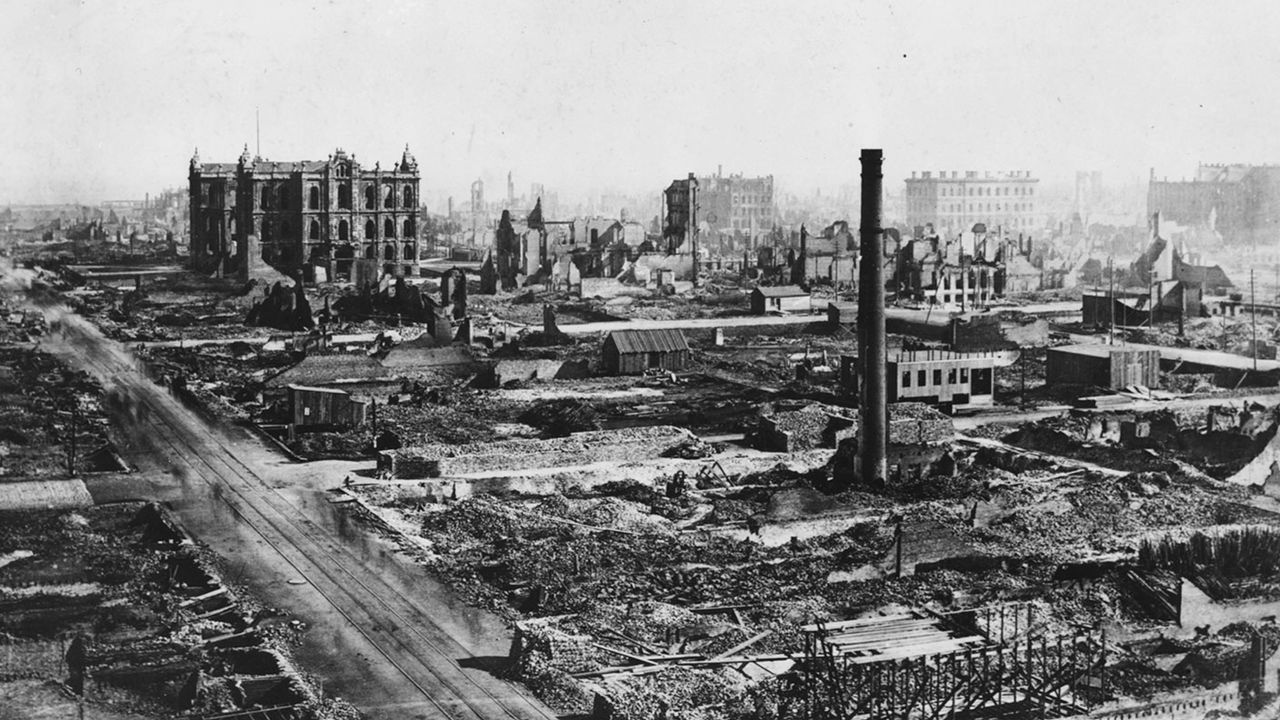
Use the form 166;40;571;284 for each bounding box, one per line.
856;147;888;484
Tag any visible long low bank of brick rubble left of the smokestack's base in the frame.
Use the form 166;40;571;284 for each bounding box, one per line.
378;425;694;479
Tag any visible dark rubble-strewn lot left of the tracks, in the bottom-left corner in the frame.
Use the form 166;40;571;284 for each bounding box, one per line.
0;502;346;719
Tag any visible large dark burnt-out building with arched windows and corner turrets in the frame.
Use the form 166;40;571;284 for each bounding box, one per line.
188;146;419;281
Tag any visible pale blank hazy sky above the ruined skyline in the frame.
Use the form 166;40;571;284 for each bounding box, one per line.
0;0;1280;202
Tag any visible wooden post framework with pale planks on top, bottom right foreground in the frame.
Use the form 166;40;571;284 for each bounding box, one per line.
795;603;1106;720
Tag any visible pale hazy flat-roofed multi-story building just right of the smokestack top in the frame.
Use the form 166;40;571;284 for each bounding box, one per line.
906;170;1039;232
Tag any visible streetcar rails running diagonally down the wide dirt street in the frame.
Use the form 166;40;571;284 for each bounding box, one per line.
40;308;556;720
